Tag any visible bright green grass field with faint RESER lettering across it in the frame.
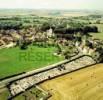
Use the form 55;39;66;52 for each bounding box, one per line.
0;46;63;78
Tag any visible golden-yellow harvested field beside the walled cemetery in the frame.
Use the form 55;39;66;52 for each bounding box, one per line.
40;64;103;100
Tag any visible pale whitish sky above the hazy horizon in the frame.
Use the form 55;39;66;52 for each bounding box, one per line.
0;0;103;10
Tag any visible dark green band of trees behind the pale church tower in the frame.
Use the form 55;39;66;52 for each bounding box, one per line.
40;23;98;34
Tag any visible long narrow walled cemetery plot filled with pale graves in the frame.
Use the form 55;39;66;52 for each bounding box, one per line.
9;56;96;96
